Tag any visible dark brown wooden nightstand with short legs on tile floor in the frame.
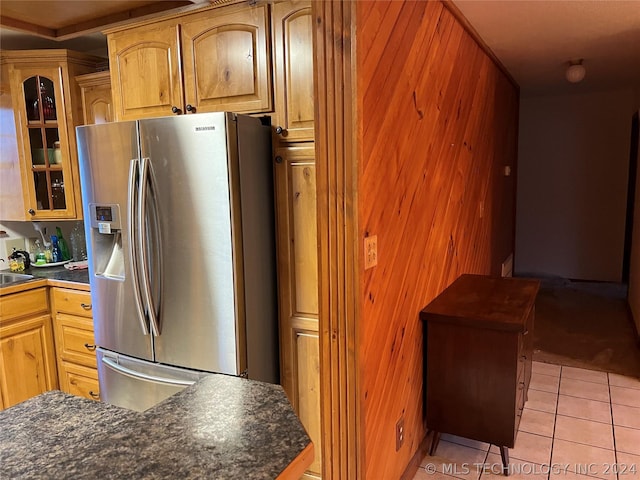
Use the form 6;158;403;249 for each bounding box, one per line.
420;275;540;474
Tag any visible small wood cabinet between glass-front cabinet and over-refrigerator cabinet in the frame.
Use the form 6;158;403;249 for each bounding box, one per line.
76;70;114;125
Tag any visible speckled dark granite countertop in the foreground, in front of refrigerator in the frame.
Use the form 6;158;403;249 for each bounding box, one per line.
0;375;313;480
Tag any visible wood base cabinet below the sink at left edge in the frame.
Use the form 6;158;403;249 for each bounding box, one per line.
0;287;58;408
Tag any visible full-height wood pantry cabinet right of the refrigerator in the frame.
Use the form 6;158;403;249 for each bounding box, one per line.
271;1;322;479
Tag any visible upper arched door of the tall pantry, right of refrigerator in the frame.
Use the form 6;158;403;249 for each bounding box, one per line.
272;1;314;142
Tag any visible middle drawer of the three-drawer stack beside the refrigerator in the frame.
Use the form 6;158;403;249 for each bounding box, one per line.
55;313;96;368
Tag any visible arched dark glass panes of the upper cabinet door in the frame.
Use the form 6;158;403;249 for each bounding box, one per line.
23;75;67;210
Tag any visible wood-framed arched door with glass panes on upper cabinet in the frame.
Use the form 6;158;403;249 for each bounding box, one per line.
12;68;76;220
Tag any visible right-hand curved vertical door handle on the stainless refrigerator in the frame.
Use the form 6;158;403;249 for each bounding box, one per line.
137;158;162;337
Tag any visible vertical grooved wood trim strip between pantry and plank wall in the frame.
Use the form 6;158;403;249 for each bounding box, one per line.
311;0;360;480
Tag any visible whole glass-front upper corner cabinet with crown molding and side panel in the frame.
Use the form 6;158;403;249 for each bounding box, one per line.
0;50;101;220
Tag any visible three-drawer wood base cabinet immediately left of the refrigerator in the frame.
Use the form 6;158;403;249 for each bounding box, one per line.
51;288;100;400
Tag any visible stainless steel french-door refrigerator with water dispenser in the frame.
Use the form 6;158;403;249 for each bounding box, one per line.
77;112;278;411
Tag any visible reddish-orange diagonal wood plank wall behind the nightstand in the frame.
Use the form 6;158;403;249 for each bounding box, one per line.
356;1;518;479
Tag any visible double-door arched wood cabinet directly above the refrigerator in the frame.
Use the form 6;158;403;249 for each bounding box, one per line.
108;5;272;120
